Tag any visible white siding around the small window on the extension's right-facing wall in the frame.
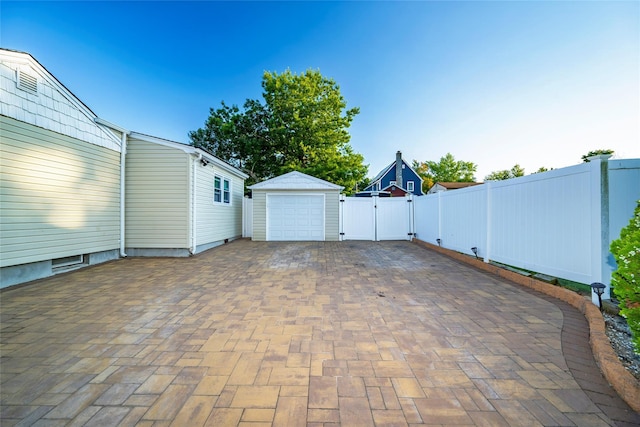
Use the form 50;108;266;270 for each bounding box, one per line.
196;162;244;246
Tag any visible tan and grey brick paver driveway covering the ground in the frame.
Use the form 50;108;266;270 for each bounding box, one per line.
0;240;636;426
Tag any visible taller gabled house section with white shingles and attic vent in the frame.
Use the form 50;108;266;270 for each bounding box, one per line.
0;49;124;287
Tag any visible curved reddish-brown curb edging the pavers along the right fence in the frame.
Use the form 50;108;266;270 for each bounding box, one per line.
414;239;640;412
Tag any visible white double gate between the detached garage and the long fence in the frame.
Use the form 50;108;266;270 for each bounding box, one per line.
340;196;413;241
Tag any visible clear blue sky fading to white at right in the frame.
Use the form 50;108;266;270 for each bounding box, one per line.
0;0;640;180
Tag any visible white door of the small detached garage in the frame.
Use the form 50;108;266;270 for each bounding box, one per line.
267;194;324;241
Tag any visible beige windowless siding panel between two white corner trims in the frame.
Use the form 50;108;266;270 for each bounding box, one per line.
125;139;190;249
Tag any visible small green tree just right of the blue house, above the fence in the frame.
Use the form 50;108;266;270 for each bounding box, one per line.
412;153;478;191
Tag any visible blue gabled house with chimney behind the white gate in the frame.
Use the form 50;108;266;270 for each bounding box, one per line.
356;151;423;197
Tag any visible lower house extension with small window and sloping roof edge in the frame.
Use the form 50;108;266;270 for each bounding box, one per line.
120;132;247;256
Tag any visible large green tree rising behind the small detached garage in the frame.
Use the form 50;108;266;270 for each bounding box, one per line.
189;70;368;194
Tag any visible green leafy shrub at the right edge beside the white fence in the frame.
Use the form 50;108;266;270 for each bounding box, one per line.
611;200;640;354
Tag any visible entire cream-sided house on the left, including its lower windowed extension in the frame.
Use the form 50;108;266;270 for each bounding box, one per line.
0;49;247;288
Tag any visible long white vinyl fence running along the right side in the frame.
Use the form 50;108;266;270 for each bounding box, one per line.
415;158;640;300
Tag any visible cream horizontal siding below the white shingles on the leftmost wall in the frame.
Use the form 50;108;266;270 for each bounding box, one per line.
0;116;120;267
